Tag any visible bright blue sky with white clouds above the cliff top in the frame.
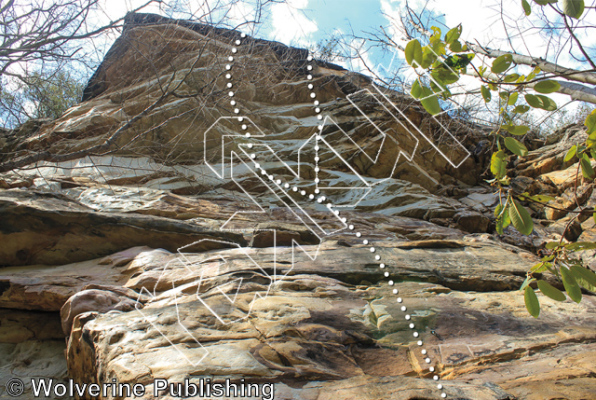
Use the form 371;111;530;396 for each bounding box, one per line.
98;0;596;125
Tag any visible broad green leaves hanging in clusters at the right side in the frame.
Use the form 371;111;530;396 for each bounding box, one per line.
404;0;596;317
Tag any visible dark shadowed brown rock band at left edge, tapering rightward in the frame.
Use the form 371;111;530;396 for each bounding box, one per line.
0;190;245;266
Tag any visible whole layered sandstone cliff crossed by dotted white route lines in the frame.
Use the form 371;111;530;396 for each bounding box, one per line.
0;15;596;400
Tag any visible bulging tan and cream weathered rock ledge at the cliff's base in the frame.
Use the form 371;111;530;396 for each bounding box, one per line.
59;245;596;399
